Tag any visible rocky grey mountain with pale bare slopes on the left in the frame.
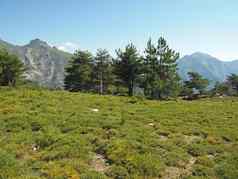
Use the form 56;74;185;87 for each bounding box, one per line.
0;39;71;88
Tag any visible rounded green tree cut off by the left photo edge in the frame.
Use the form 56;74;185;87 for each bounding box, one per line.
0;50;25;86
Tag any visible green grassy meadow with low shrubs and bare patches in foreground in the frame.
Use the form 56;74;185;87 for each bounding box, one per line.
0;88;238;179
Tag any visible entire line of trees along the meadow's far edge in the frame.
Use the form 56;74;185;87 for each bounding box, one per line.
0;37;238;99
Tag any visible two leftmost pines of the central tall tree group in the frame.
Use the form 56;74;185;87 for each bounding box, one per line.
65;49;113;94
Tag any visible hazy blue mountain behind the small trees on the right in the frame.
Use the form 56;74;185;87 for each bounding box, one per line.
178;52;238;83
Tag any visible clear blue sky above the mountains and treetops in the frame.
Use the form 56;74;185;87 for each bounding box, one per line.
0;0;238;60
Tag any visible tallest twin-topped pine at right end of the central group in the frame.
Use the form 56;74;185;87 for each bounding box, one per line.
144;37;180;99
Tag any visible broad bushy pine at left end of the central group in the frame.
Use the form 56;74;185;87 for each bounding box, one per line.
65;51;93;91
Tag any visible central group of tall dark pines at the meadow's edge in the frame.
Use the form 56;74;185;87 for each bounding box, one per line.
65;37;181;99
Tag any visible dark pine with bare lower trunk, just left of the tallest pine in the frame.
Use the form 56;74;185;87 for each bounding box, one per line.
115;44;141;96
